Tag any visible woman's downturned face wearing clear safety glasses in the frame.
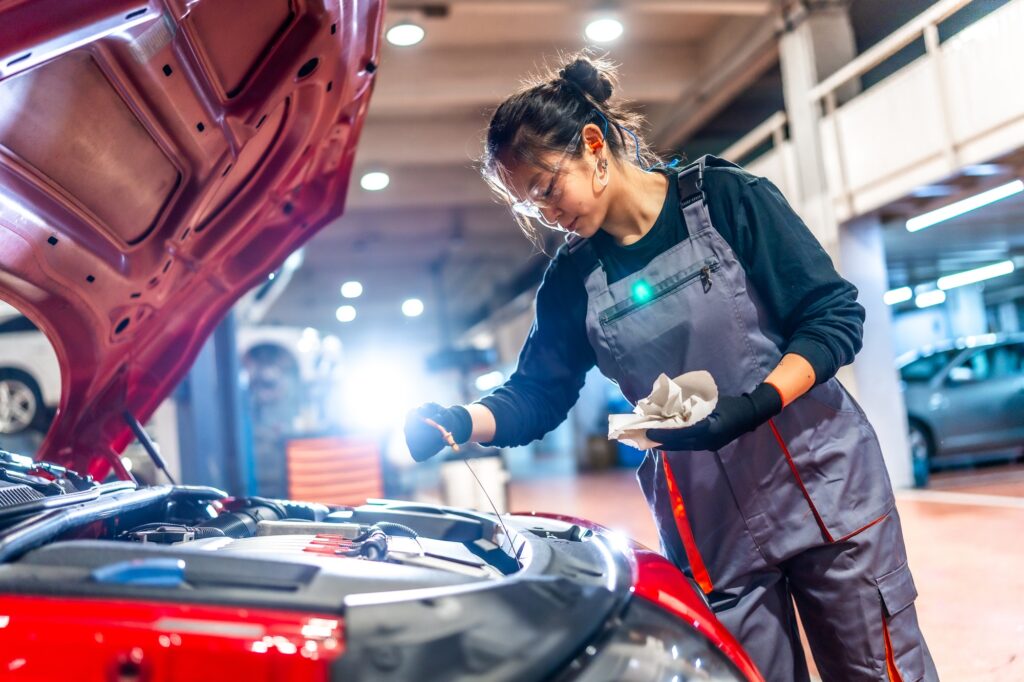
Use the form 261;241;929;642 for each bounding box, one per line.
510;126;608;238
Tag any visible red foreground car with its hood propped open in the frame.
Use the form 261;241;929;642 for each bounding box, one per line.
0;0;761;682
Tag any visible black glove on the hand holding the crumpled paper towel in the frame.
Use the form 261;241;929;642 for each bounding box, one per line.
647;384;782;451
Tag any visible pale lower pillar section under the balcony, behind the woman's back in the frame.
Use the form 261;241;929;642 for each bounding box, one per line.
840;218;912;487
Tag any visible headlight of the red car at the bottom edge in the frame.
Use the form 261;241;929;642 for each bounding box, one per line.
560;598;745;682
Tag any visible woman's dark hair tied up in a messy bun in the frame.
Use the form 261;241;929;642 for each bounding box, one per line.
480;52;659;246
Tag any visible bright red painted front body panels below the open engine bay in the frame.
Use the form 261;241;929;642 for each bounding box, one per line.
0;515;762;682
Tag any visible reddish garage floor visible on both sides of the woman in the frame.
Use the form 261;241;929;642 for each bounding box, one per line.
510;466;1024;682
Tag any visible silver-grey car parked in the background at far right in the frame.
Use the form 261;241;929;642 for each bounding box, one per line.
897;334;1024;484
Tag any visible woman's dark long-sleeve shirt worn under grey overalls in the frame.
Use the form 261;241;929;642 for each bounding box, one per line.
480;159;864;446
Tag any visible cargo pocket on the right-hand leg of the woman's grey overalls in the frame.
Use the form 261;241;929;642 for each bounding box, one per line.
874;563;925;682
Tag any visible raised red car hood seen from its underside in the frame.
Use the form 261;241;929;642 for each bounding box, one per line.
0;0;383;477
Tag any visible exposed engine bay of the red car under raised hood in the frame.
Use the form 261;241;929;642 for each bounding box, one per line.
0;444;589;609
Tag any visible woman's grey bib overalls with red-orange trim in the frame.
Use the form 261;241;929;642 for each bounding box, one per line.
568;158;937;682
